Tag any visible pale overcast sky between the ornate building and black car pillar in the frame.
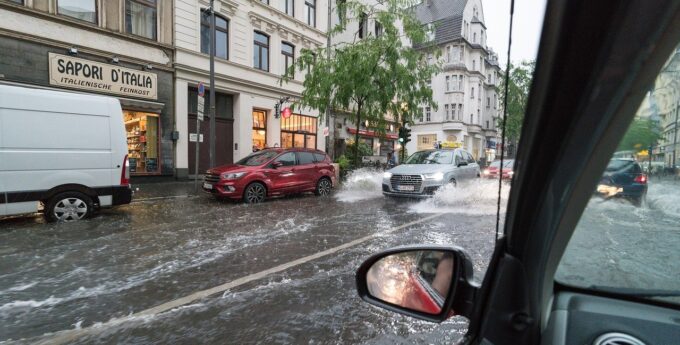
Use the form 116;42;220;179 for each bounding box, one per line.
482;0;545;68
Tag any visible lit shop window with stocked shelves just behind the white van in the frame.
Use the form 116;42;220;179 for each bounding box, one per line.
123;110;160;175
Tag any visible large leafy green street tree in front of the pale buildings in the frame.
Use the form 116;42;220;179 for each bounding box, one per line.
282;0;439;165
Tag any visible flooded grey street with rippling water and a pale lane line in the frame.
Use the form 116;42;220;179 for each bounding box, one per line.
0;171;680;344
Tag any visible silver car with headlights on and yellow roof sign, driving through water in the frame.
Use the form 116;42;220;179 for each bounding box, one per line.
383;149;480;198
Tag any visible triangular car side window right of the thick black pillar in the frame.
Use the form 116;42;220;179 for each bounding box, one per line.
556;42;680;304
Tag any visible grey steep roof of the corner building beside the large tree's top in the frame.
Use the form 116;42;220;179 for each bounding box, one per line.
415;0;467;44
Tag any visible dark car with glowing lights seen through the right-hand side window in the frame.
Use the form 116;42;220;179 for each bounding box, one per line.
597;158;647;206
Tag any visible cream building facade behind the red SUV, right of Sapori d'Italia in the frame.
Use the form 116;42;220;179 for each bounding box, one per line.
174;0;328;174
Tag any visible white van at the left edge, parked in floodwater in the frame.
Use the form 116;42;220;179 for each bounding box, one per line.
0;85;132;221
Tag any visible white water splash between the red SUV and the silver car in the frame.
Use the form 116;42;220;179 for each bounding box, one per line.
335;168;383;202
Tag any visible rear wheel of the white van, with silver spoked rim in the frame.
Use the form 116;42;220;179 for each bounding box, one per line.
44;192;94;222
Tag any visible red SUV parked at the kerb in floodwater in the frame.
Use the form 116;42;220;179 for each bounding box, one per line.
203;148;336;204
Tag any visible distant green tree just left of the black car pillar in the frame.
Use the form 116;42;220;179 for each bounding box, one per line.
497;61;536;155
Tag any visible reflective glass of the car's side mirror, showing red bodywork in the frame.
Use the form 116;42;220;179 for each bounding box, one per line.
366;250;454;315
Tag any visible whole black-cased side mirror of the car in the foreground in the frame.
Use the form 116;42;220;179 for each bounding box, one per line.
356;246;477;322
